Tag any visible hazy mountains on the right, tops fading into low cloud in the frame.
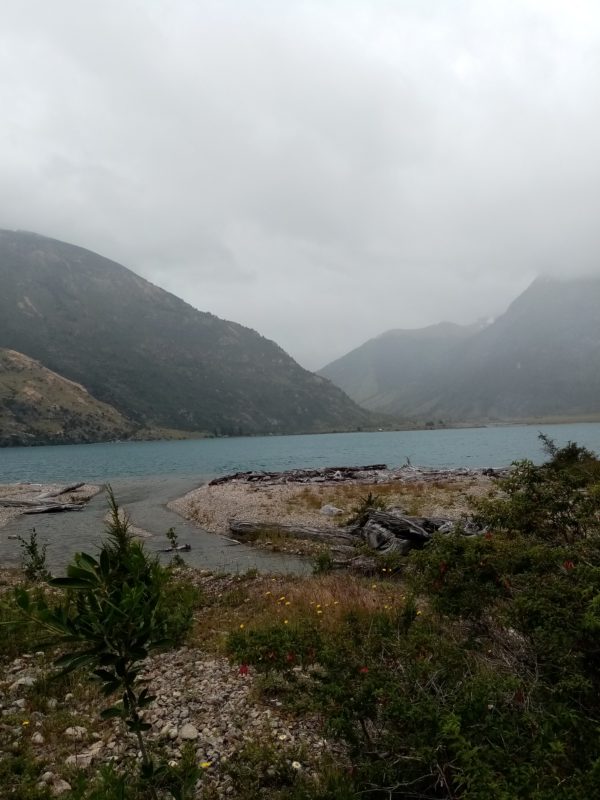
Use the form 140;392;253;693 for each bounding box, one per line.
319;278;600;424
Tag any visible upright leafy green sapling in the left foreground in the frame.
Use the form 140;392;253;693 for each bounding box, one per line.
16;488;190;798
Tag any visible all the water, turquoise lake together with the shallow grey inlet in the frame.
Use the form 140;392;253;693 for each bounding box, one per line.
0;423;600;572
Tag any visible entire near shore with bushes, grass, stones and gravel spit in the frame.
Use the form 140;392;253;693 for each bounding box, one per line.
0;440;600;800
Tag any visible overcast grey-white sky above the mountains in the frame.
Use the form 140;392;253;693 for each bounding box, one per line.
0;0;600;369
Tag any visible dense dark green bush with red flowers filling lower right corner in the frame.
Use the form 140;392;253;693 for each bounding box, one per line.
230;445;600;800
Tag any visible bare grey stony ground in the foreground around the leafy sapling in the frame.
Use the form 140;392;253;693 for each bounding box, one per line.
0;571;342;798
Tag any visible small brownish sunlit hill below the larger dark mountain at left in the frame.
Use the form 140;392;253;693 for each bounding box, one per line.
0;349;131;446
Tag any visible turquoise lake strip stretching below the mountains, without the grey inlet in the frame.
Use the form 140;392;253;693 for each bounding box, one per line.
0;423;600;483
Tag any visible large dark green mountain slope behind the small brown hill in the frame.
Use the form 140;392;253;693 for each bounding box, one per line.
0;231;371;434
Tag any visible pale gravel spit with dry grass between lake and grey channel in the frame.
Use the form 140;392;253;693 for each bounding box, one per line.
167;467;501;555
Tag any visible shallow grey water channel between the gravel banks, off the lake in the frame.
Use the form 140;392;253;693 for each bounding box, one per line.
0;476;311;574
